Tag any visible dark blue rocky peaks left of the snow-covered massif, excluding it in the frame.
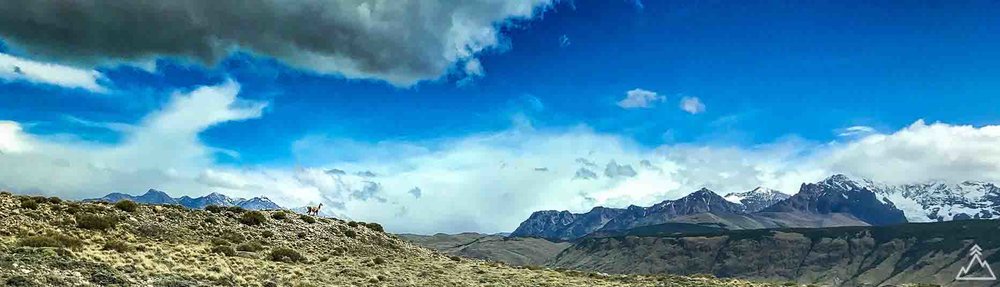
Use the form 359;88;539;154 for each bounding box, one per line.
511;177;916;241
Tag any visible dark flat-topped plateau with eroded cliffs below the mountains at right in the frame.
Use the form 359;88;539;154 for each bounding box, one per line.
549;220;1000;286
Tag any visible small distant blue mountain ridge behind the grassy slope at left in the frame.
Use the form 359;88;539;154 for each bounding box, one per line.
84;189;282;210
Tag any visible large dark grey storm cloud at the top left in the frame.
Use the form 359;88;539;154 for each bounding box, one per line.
0;0;549;86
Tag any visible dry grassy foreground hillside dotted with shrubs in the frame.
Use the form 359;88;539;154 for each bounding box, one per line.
0;193;767;286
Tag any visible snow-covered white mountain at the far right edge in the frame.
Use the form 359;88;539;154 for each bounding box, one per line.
862;179;1000;222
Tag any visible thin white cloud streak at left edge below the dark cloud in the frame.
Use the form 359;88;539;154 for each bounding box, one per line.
0;53;107;93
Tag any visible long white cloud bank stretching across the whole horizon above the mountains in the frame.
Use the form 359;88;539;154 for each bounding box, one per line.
0;82;1000;232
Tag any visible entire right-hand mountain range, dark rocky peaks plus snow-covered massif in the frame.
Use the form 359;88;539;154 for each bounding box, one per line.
511;174;1000;241
